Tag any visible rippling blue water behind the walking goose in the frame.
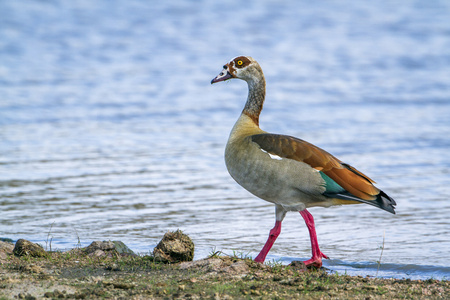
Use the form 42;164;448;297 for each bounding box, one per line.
0;0;450;279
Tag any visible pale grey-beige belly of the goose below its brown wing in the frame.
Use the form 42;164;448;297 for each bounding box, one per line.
225;141;325;211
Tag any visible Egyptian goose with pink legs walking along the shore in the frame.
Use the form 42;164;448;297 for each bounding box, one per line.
211;56;396;268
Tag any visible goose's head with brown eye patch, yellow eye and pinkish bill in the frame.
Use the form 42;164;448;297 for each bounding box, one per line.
211;56;262;84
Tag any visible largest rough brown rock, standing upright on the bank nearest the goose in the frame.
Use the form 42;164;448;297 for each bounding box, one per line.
153;230;194;263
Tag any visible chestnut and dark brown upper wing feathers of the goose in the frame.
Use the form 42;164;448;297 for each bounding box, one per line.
251;133;380;200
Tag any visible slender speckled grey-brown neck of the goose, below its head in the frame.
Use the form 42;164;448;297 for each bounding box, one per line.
242;72;266;126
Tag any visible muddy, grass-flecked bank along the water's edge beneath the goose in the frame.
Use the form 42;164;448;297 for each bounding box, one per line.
0;238;450;299
